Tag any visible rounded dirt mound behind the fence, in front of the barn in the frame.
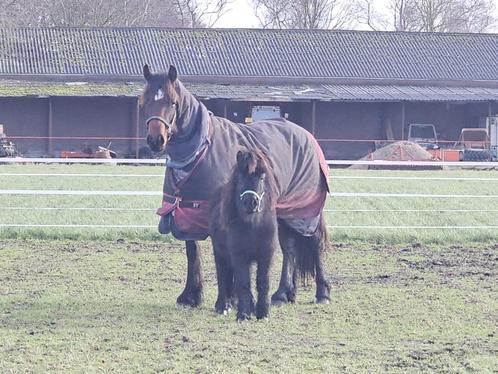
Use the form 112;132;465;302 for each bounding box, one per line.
350;141;441;170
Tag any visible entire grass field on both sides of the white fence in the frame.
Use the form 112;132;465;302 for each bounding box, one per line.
0;165;498;373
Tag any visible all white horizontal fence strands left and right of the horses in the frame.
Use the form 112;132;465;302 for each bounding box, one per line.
0;163;498;230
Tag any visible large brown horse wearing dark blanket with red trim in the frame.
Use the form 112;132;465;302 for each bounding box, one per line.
141;65;330;306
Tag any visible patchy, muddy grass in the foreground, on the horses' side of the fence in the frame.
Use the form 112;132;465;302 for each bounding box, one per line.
0;240;498;373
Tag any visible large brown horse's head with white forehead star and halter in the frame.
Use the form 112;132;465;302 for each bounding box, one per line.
140;65;179;152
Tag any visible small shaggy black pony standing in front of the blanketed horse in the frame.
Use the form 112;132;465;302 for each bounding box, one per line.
210;150;278;321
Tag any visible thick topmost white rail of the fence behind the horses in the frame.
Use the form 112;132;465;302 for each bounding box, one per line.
0;157;498;168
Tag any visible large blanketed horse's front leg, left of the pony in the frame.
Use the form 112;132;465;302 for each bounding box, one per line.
176;240;202;307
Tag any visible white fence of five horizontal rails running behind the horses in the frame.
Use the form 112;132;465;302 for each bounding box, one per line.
0;158;498;230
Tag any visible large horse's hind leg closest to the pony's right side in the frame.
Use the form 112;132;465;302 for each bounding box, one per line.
271;223;296;305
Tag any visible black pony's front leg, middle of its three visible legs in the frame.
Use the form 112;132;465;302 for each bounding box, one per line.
233;257;254;321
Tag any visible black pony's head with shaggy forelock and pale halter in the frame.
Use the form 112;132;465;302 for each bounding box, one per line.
234;150;275;214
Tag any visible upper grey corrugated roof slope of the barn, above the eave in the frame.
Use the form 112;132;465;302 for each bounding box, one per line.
0;28;498;82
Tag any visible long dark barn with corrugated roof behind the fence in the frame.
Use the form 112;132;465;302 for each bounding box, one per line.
0;28;498;159
